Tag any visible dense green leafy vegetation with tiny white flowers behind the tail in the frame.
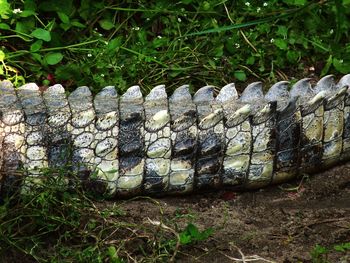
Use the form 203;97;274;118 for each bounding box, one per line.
0;0;350;92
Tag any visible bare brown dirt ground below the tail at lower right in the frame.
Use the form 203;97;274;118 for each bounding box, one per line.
118;164;350;263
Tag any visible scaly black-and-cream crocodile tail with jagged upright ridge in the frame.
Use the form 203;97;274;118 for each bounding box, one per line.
0;74;350;198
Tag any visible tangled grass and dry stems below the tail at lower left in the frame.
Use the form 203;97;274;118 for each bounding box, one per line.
0;172;213;263
